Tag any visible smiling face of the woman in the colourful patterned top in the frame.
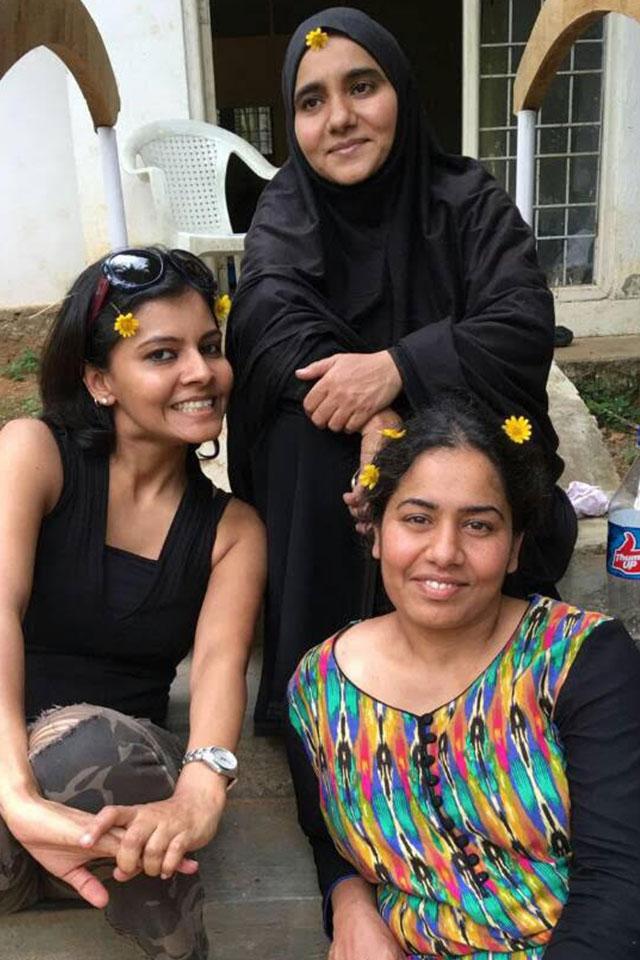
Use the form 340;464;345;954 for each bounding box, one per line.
373;447;522;631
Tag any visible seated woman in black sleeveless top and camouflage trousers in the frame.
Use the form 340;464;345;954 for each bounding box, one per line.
0;248;264;960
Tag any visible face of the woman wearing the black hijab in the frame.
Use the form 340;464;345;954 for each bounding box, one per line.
294;36;398;185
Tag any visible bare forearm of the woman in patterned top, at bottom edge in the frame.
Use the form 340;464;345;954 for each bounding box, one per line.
327;877;406;960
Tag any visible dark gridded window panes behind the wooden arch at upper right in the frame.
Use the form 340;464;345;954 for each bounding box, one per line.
480;0;604;284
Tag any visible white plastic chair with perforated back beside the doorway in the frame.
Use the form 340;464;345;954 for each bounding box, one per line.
122;120;278;291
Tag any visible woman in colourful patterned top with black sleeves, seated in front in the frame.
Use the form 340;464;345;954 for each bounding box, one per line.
289;397;640;960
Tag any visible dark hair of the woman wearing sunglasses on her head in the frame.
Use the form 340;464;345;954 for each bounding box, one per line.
39;247;215;454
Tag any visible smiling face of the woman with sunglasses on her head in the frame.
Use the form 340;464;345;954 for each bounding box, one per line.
85;287;233;444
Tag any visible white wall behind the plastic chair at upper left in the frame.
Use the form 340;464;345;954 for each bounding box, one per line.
0;0;189;307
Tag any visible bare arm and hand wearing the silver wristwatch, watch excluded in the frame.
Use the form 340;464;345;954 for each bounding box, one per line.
83;500;266;879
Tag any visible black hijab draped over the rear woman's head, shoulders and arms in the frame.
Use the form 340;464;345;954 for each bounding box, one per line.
227;7;561;481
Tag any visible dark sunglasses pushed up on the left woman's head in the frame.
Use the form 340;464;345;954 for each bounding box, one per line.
89;249;216;325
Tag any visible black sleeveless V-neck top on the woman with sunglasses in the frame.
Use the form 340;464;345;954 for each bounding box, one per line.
23;429;230;723
